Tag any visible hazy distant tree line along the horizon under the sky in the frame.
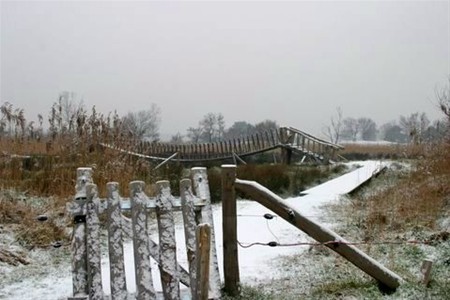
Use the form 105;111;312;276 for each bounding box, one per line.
0;77;450;144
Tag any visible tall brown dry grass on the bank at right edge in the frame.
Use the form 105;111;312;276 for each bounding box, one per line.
361;142;450;240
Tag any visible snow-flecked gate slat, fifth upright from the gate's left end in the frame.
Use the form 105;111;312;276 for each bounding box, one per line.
156;180;180;300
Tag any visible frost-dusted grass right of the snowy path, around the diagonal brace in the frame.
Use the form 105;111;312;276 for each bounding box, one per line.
223;142;450;299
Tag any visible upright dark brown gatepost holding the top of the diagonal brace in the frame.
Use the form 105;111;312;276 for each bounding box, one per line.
222;165;239;296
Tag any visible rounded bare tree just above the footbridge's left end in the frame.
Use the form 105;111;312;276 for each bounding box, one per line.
122;103;161;141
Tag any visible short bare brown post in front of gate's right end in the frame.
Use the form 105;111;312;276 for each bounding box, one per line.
193;224;211;300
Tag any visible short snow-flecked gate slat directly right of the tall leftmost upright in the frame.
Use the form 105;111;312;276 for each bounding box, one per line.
86;183;103;300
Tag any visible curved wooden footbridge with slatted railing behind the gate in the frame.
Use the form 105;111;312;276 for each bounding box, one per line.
102;127;343;164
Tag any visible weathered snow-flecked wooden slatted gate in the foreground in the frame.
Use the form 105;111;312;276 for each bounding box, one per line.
67;168;220;300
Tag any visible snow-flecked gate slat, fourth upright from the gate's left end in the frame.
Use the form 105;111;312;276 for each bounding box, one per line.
130;181;156;300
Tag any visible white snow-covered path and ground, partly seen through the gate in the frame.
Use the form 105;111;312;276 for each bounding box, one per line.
0;161;386;300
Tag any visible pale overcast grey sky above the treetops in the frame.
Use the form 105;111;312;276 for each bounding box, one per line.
0;1;450;136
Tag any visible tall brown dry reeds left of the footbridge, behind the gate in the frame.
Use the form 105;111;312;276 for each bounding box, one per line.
0;103;163;247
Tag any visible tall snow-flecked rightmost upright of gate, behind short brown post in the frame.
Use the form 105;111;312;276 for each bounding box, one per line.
191;167;221;299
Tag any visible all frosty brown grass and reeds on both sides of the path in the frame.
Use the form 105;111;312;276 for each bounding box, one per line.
0;86;450;299
